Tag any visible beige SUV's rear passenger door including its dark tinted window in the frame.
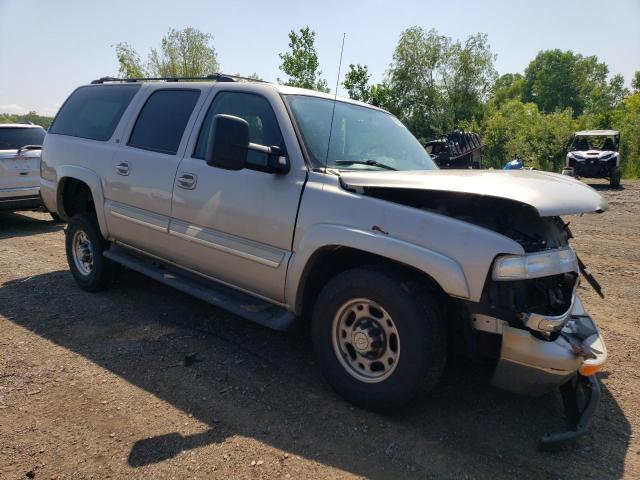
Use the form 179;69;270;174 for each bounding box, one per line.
103;85;205;256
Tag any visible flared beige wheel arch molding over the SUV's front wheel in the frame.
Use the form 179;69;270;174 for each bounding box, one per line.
285;224;470;305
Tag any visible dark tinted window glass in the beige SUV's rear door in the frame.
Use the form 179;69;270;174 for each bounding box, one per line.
129;89;200;155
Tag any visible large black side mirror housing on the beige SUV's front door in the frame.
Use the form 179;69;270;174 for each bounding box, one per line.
205;114;249;170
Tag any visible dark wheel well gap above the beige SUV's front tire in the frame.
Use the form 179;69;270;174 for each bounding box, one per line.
296;246;450;319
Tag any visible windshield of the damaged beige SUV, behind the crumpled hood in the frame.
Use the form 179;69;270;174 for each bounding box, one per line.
285;95;438;170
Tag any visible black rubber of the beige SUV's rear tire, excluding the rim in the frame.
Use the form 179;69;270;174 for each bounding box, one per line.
65;213;115;292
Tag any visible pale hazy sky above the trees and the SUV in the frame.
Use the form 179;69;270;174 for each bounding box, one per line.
0;0;640;115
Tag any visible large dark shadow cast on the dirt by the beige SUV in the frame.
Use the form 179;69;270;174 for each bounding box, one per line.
0;215;631;479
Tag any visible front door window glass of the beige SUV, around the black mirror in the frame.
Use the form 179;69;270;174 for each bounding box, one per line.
193;92;284;166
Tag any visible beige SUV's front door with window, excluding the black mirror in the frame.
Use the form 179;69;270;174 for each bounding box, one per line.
169;91;306;301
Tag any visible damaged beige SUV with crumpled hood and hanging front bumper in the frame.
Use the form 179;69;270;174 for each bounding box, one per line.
41;75;607;446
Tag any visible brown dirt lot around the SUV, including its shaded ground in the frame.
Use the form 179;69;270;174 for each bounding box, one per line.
0;178;640;479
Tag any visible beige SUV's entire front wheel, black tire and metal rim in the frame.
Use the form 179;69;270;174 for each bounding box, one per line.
312;267;446;411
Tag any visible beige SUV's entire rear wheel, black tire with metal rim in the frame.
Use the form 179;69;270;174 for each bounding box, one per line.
65;213;115;292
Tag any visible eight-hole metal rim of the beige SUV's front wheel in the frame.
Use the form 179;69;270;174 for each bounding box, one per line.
331;298;400;383
